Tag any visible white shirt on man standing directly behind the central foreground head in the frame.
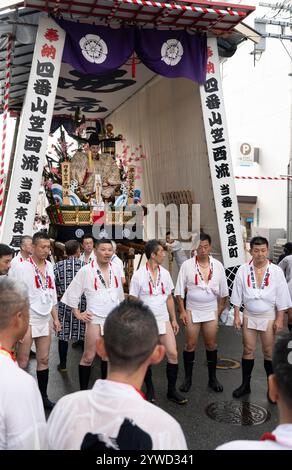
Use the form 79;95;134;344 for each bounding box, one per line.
129;266;174;321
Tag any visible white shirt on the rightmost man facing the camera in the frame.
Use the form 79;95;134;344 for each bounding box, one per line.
230;263;291;314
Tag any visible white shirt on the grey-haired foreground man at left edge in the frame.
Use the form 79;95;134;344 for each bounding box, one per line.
0;351;46;450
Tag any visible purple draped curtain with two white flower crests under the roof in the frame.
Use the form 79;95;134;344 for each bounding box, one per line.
56;19;207;83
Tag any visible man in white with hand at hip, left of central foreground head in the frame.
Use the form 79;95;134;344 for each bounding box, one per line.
61;239;124;390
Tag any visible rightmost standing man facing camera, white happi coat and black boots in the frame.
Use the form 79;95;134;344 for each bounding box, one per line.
230;237;291;401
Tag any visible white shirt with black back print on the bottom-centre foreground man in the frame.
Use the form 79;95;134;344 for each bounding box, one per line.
48;380;187;450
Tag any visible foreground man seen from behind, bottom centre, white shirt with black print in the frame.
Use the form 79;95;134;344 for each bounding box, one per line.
48;300;187;450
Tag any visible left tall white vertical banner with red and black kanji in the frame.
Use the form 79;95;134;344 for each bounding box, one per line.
1;18;65;248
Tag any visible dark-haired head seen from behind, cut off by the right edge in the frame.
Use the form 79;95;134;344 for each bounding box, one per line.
269;333;292;414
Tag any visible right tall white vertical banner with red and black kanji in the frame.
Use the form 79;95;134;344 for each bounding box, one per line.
200;38;245;269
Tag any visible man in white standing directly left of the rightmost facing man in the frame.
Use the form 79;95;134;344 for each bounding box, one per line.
175;233;228;392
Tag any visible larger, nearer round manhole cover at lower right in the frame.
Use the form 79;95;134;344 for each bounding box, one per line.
205;400;271;426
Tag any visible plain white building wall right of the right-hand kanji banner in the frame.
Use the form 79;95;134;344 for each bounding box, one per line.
222;1;292;228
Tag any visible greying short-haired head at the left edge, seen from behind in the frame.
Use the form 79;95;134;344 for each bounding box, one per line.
0;277;29;344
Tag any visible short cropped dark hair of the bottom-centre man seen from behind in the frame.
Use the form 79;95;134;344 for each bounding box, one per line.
104;299;159;372
